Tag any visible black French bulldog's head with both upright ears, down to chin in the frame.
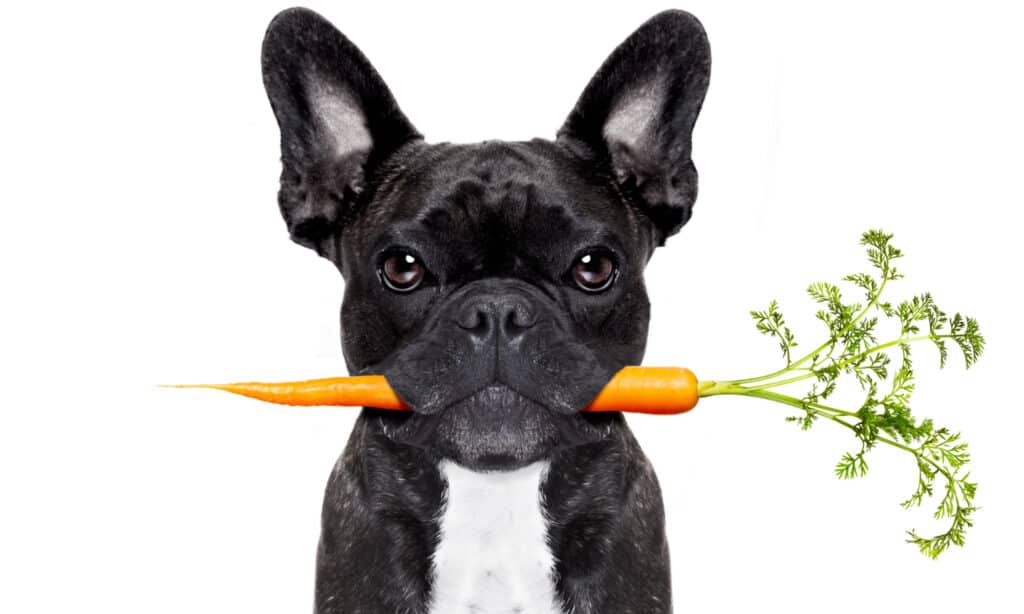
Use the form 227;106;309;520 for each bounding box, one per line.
262;9;710;469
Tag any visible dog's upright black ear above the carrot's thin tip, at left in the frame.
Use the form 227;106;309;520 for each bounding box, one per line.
262;8;421;251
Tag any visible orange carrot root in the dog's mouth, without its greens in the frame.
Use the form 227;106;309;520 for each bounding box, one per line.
165;366;697;414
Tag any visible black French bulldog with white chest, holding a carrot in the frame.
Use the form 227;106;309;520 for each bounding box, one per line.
262;9;710;614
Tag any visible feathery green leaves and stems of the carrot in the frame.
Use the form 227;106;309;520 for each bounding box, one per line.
698;230;985;559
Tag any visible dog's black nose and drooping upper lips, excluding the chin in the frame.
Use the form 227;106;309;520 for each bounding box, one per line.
381;279;616;420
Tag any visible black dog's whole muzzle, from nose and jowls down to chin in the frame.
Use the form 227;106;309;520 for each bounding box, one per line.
366;279;629;470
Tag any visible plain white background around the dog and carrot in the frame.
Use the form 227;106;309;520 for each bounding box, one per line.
0;0;1024;613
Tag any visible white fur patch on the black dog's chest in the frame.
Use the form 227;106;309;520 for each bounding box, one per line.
430;461;563;614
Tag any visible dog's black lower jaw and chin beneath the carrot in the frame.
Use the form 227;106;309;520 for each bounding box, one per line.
378;384;612;471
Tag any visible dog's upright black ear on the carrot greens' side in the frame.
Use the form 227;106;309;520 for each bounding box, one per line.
558;10;711;245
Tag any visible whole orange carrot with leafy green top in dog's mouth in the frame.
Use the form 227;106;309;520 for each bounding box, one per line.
165;230;985;558
